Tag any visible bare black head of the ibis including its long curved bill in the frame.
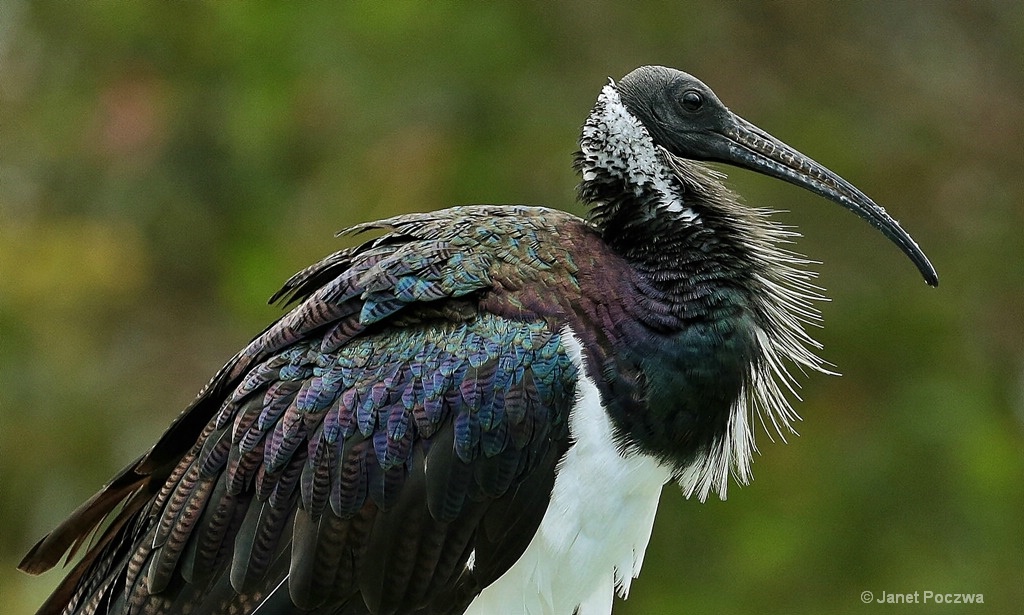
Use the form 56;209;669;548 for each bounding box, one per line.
613;67;938;287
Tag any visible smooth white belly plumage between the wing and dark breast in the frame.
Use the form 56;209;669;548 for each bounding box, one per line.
466;326;671;615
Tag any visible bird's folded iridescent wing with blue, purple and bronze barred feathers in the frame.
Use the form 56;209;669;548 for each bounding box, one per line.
20;207;579;613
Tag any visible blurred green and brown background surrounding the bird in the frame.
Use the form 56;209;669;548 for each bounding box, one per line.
0;0;1024;614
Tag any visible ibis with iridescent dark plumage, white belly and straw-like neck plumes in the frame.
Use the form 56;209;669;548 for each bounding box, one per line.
19;65;938;615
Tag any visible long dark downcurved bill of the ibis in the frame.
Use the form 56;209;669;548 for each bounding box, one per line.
722;114;939;287
